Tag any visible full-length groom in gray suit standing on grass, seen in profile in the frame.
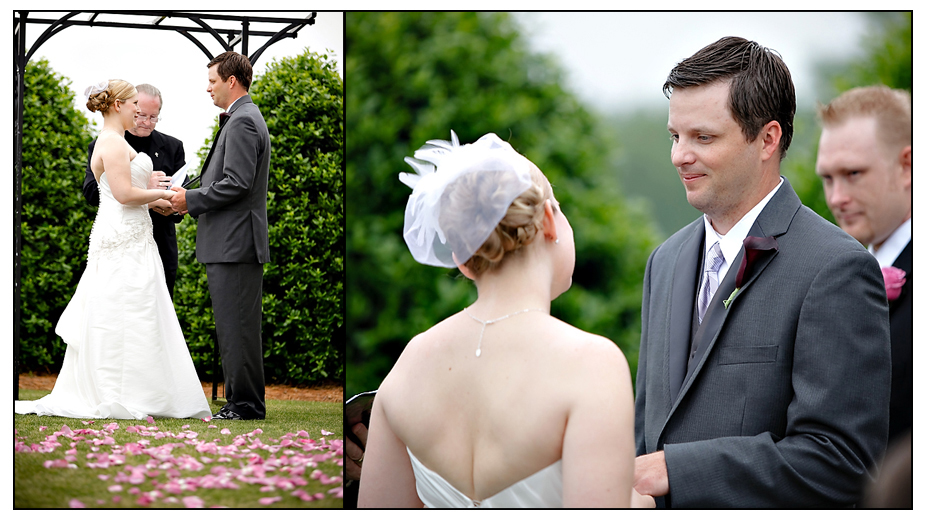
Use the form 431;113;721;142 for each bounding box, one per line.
171;51;270;420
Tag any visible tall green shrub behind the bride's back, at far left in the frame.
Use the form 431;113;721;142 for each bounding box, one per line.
19;59;96;372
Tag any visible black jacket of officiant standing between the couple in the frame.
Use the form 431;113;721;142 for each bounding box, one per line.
83;130;185;270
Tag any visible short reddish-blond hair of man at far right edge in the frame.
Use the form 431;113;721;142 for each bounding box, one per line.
818;86;911;152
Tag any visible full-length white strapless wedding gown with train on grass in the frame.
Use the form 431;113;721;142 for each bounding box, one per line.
14;153;210;419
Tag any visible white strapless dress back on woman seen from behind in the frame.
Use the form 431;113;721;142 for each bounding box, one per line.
406;448;563;508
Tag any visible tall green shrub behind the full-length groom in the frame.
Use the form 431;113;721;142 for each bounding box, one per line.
174;50;344;384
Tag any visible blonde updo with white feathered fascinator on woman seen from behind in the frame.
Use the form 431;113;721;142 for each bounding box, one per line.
399;131;551;275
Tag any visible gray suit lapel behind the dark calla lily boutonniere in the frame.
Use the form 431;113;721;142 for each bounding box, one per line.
671;178;801;415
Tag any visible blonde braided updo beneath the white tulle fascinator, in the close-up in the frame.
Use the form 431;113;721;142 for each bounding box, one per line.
440;164;556;276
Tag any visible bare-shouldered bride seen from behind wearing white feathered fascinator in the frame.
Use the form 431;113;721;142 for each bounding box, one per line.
356;132;634;508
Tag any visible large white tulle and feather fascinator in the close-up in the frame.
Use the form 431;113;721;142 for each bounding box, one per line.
399;130;531;268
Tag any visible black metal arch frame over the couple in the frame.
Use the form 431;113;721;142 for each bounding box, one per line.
13;10;316;400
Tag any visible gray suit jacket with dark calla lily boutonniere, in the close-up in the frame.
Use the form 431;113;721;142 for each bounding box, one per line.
635;181;891;508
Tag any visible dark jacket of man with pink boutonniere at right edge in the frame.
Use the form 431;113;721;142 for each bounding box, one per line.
888;240;914;442
